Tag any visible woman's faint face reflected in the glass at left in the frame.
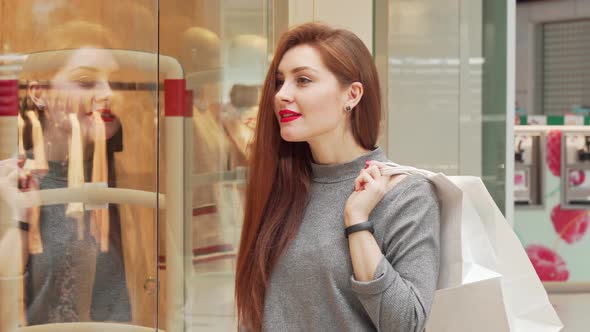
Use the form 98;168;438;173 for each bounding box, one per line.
44;48;121;139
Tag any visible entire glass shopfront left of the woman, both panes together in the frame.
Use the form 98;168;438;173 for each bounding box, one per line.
0;0;277;331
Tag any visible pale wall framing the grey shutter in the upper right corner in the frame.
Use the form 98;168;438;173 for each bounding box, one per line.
516;0;590;114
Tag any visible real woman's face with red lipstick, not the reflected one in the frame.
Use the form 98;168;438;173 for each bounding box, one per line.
274;45;348;142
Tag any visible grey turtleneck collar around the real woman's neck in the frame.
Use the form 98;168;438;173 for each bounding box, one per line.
311;148;387;183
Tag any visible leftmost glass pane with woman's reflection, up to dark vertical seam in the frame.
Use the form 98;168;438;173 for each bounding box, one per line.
0;0;162;331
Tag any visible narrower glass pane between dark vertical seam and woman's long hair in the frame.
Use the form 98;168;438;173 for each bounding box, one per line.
158;0;272;331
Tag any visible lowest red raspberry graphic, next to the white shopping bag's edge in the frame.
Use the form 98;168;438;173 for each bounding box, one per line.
526;244;570;281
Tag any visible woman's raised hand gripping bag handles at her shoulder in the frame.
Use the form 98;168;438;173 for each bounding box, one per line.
344;160;391;227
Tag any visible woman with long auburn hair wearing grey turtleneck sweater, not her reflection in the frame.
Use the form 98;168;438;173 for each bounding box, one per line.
236;23;439;332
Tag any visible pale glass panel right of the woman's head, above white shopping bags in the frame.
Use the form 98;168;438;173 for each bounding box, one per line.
382;0;512;213
